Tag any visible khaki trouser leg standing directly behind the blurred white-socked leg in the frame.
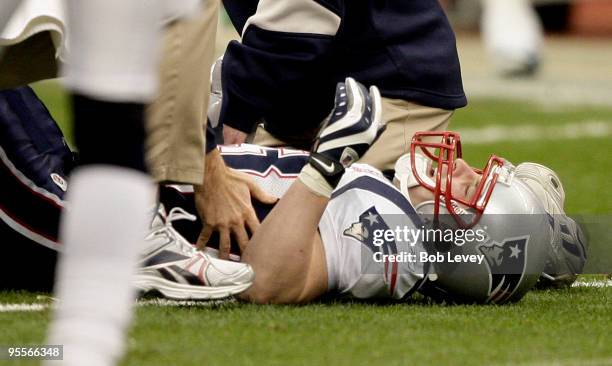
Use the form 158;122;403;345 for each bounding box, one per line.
146;0;219;184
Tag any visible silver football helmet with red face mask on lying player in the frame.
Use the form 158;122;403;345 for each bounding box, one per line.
404;132;552;304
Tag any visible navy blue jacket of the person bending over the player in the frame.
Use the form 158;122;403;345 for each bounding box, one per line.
221;0;467;142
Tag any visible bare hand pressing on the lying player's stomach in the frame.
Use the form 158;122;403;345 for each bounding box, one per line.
195;149;277;259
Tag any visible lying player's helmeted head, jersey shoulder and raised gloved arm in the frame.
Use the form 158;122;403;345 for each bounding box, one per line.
202;79;585;303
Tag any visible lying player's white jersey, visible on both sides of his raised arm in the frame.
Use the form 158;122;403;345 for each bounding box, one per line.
219;144;427;299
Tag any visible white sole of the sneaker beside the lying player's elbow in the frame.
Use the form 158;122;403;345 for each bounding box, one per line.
134;274;252;300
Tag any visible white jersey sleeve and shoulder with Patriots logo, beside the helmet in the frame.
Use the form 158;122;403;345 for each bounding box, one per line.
319;164;427;299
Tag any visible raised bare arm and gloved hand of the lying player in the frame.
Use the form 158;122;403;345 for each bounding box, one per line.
242;79;382;303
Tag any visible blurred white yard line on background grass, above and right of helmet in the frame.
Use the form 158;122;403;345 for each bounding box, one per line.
459;120;612;144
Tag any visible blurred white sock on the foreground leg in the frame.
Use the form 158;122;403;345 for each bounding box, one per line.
47;165;155;365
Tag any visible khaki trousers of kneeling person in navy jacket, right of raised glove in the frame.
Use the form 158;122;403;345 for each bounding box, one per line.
359;98;454;171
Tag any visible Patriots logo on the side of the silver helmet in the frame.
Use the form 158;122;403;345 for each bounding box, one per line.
477;236;529;304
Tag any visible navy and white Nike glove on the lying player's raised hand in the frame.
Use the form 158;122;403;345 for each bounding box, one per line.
309;78;385;187
